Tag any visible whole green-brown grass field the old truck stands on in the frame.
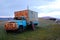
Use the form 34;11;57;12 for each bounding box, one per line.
0;20;60;40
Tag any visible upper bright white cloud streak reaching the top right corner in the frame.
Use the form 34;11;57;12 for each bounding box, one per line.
37;1;60;9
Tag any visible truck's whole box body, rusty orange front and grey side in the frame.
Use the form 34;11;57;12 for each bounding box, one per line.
15;10;38;21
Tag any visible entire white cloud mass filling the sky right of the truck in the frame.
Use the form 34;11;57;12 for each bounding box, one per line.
34;0;60;18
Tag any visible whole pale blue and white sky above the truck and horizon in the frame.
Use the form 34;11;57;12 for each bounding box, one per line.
0;0;60;18
